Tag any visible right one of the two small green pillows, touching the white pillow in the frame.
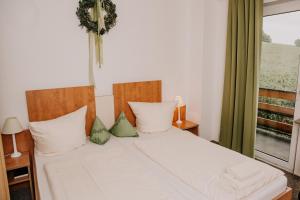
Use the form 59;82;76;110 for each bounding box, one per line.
109;112;139;137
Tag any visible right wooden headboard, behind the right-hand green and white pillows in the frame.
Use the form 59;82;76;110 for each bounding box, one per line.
113;80;162;126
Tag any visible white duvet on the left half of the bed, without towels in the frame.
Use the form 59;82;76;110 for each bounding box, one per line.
45;139;183;200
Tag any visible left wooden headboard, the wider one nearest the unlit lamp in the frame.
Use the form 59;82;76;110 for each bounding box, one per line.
26;86;96;135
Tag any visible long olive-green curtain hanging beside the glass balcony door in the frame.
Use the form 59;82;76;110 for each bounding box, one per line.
220;0;263;157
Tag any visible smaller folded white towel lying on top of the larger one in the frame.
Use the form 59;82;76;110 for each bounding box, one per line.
226;160;261;181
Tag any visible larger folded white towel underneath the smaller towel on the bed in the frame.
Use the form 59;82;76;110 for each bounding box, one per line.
223;172;264;190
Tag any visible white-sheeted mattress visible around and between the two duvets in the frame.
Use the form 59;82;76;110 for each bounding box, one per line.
35;128;287;200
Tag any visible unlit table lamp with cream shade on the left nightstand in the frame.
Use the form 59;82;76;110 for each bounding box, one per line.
2;117;24;158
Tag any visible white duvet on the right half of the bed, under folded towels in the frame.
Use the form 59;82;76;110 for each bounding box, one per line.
135;130;283;200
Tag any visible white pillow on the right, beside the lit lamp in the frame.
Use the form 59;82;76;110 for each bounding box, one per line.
128;101;176;133
